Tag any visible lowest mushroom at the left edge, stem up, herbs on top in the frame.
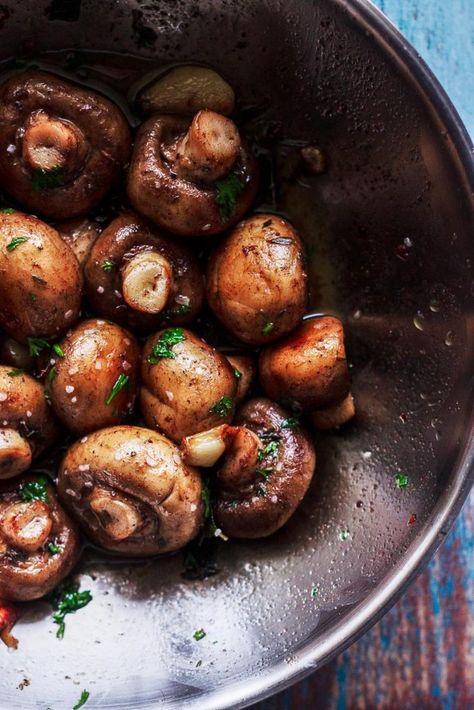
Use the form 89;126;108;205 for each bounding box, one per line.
0;475;81;601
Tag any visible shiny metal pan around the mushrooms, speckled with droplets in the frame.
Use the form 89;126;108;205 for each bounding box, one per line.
0;0;474;710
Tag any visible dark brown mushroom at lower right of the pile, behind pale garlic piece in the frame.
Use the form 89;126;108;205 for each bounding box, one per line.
214;398;316;538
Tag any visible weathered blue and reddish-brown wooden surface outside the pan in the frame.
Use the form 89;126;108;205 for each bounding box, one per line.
255;0;474;710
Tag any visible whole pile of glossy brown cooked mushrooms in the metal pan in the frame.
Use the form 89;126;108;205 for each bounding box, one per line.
0;66;354;644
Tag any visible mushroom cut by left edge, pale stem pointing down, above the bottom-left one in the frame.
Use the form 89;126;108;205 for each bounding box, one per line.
0;365;59;482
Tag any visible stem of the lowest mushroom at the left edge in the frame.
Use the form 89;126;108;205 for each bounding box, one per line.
0;500;53;552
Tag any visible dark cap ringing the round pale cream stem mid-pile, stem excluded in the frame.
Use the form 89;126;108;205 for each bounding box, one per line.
85;213;204;333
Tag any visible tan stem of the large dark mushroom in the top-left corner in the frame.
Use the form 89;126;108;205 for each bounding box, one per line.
22;111;85;172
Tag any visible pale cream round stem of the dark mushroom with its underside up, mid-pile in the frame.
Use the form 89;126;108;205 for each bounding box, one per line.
122;251;173;313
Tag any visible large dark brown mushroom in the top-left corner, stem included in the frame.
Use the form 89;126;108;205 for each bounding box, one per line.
0;71;130;219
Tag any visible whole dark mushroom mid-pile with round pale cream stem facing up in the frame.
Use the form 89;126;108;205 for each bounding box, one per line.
85;213;204;333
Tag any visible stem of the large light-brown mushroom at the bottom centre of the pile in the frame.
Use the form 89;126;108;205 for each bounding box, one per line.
89;488;142;541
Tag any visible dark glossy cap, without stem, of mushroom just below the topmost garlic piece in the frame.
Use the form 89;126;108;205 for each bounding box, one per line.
127;112;258;236
